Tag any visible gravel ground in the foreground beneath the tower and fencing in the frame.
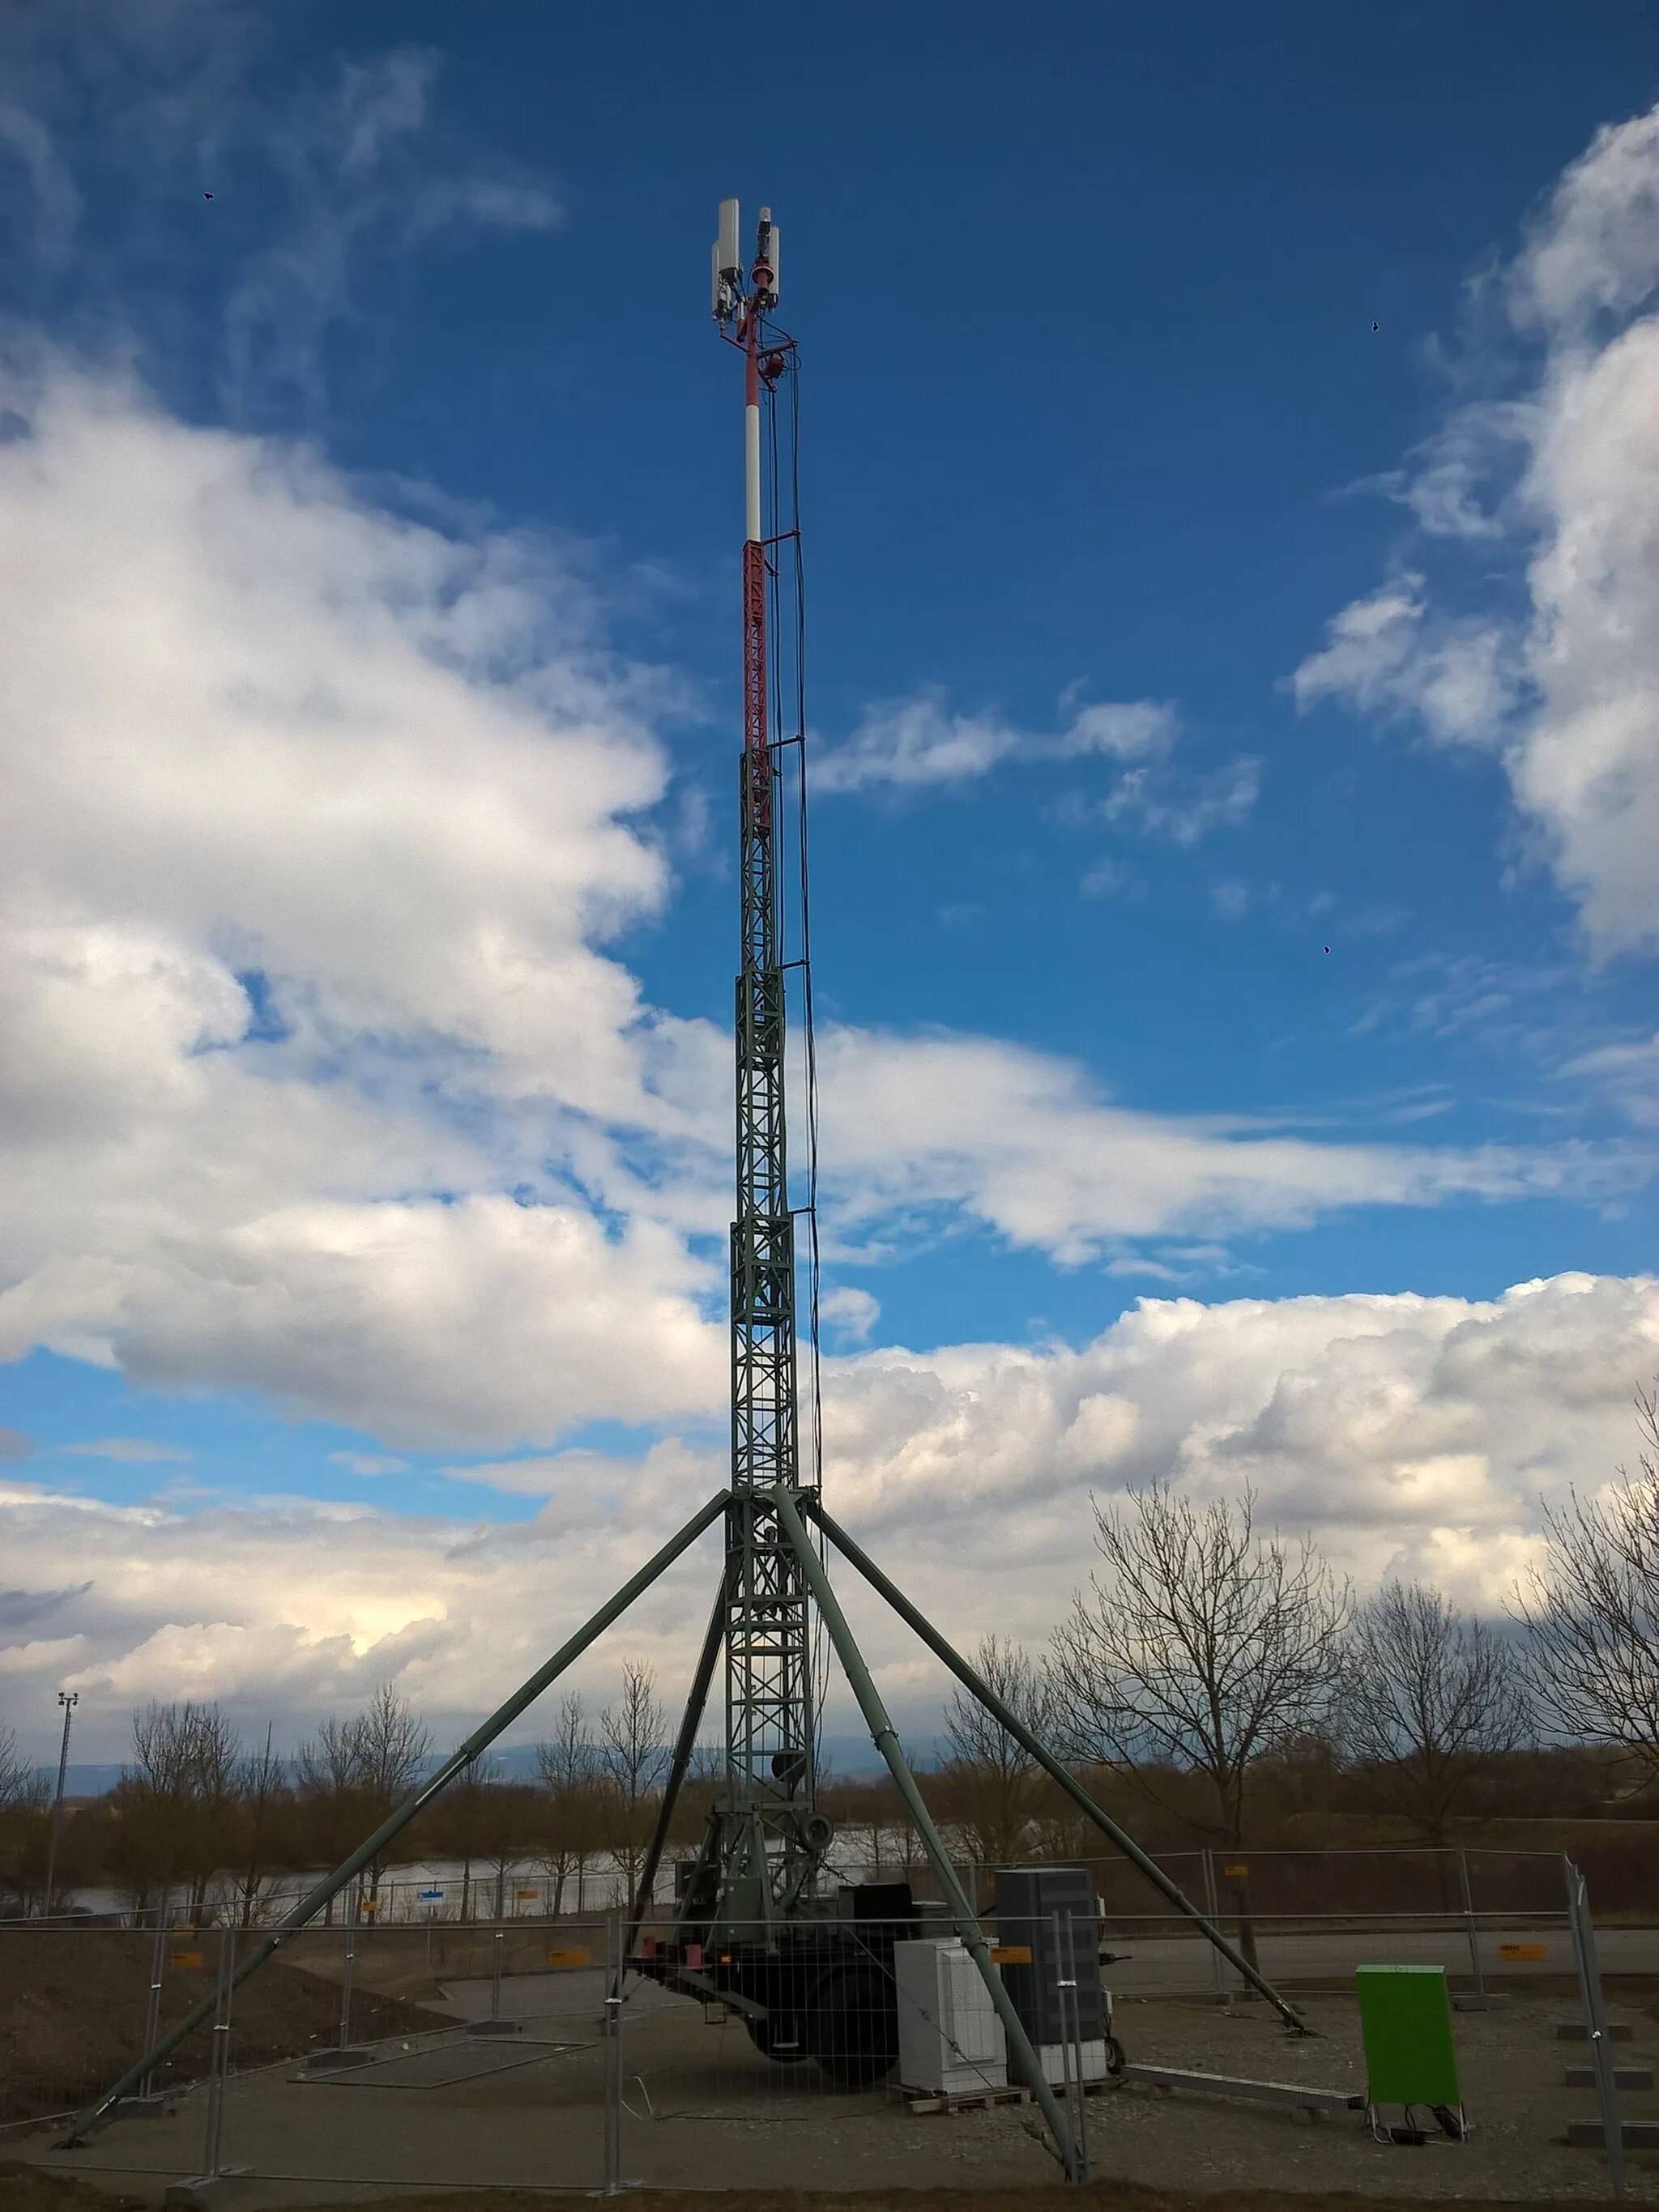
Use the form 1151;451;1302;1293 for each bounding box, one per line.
16;1975;1659;2212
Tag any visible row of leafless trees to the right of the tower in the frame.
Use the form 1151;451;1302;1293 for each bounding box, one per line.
947;1392;1659;1858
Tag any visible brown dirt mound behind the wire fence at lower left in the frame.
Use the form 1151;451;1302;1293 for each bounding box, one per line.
0;1929;440;2123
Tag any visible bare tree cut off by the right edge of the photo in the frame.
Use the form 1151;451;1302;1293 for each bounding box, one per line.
1516;1383;1659;1776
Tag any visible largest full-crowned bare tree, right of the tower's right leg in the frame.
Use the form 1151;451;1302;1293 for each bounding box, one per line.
1053;1485;1351;1847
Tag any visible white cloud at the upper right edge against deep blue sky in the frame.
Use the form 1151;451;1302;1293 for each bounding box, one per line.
1292;109;1659;953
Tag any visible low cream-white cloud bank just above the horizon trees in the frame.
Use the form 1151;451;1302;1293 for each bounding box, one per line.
0;1274;1659;1756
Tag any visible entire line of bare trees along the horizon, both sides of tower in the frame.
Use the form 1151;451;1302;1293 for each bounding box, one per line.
0;1392;1659;1924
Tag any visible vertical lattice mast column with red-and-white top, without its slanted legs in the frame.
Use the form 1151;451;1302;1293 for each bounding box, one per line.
699;199;830;1924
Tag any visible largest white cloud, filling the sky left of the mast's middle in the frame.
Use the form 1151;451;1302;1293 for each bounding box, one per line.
0;360;726;1447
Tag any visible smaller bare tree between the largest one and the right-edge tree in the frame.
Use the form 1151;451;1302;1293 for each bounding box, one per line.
1338;1582;1529;1843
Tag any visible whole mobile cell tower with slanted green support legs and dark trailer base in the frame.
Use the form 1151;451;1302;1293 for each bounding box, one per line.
62;199;1310;2179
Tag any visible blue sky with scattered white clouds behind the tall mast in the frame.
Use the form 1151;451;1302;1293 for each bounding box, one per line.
0;4;1659;1760
